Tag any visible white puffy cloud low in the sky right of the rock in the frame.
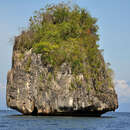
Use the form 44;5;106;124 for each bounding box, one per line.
115;80;130;103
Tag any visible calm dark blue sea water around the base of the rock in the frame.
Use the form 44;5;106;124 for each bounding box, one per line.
0;111;130;130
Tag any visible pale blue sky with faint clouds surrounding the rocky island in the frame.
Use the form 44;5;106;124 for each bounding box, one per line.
0;0;130;112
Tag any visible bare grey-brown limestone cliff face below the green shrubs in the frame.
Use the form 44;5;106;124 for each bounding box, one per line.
6;40;118;116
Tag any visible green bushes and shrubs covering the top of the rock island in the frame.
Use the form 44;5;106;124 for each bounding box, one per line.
15;3;112;89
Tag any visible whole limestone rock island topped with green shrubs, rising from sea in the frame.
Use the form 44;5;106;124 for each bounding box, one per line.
6;4;118;116
